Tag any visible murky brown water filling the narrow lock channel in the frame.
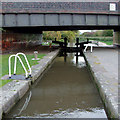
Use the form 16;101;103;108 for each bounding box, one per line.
5;53;107;118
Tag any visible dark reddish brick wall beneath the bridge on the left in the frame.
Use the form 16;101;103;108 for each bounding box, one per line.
0;31;40;52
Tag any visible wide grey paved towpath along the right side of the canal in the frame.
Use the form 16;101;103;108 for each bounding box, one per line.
85;48;120;118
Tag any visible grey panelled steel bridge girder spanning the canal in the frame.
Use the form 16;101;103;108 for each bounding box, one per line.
0;13;120;32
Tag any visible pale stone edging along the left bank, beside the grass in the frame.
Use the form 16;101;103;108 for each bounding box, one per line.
0;50;59;119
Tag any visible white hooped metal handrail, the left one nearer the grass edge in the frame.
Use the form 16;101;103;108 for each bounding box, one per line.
9;55;28;78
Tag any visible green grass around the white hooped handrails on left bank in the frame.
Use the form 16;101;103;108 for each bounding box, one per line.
0;54;45;87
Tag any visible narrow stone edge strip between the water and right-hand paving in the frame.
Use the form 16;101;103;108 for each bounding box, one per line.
84;54;120;119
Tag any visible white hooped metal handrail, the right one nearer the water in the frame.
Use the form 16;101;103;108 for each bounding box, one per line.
14;53;32;76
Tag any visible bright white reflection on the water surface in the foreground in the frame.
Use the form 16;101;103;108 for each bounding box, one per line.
35;108;105;118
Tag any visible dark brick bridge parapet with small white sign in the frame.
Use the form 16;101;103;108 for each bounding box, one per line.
1;0;120;14
